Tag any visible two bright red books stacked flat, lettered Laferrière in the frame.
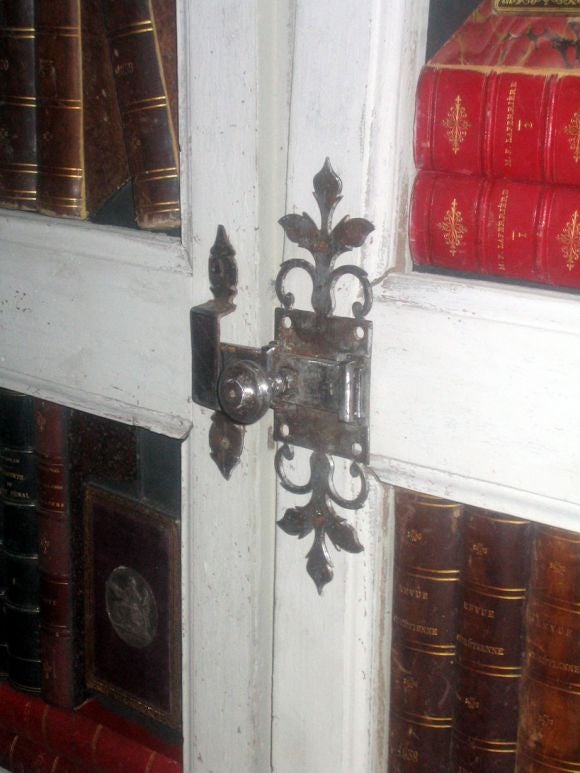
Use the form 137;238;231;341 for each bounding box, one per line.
409;0;580;289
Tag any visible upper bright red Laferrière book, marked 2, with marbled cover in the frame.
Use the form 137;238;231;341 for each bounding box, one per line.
414;0;580;185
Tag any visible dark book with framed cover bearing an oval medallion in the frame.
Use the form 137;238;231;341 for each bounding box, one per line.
84;486;181;729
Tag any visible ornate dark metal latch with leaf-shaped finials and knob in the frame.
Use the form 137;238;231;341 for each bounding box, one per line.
191;159;374;593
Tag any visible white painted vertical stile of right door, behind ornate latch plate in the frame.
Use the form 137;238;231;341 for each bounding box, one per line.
273;0;428;773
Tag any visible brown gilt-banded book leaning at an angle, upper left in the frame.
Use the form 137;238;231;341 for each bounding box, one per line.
104;0;180;230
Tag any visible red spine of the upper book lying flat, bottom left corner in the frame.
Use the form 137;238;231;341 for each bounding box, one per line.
0;685;182;773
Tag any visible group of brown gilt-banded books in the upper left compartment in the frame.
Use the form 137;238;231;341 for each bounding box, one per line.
0;0;180;230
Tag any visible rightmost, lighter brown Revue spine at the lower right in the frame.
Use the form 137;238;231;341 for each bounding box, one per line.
516;526;580;773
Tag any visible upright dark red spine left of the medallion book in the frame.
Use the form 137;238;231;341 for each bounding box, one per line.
35;400;79;708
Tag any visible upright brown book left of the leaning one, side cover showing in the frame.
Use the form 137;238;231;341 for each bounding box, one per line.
36;0;128;219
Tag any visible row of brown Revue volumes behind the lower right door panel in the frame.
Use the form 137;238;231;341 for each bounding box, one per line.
389;490;580;773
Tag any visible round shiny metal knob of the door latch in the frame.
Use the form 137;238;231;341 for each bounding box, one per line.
218;360;274;424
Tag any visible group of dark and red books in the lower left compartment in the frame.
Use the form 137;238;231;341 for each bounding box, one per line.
0;389;181;771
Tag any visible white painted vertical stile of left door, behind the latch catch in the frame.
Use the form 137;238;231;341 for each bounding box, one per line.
179;0;292;773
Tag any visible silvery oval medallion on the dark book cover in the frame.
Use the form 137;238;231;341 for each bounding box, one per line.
105;566;158;649
